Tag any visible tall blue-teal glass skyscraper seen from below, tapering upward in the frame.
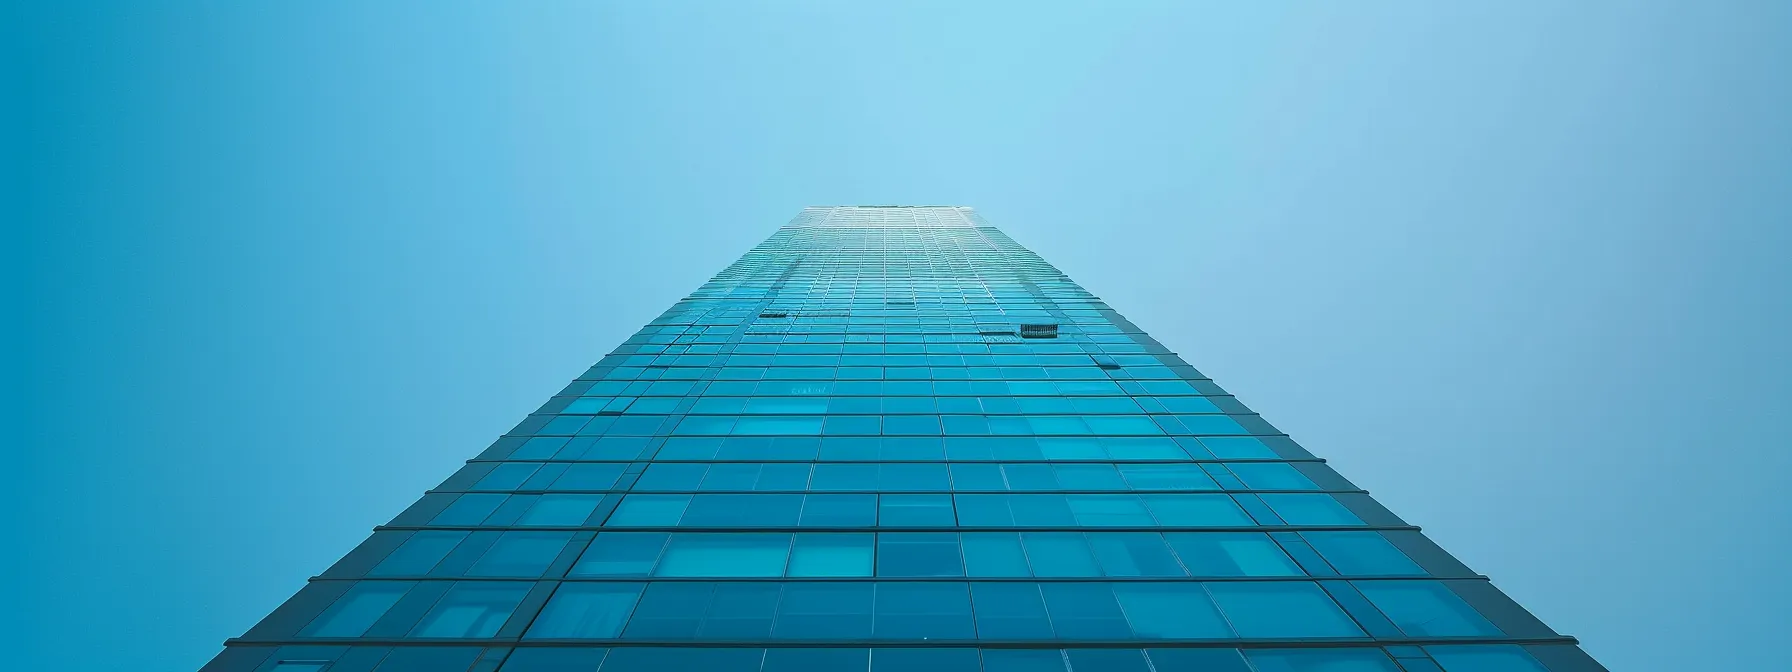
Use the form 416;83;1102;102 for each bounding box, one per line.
204;206;1604;672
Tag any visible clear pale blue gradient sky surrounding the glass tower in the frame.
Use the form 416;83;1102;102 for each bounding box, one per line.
0;0;1792;672
